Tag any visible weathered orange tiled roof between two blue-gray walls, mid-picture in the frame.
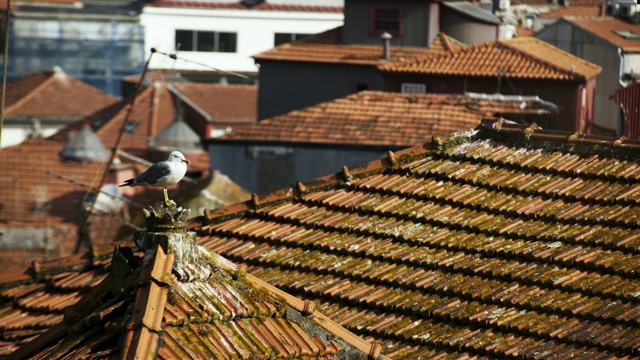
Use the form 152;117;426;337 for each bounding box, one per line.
214;91;549;148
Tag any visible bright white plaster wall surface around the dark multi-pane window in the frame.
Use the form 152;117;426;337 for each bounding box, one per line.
140;6;344;72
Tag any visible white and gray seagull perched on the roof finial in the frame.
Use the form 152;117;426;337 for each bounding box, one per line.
119;151;190;206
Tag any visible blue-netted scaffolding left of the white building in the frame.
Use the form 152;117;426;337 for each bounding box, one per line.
7;17;144;97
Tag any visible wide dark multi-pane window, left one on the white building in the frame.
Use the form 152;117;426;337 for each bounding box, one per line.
175;30;238;52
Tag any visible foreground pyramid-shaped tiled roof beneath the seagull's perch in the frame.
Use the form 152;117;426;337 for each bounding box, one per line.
9;209;382;360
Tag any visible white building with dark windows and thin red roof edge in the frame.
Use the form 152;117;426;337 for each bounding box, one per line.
140;0;344;73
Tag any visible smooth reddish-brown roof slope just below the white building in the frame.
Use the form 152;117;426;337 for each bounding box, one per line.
171;83;258;122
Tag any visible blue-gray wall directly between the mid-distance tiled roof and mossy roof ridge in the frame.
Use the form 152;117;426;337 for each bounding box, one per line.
208;143;386;194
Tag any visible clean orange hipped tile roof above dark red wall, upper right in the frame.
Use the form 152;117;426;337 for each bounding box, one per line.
378;37;602;80
